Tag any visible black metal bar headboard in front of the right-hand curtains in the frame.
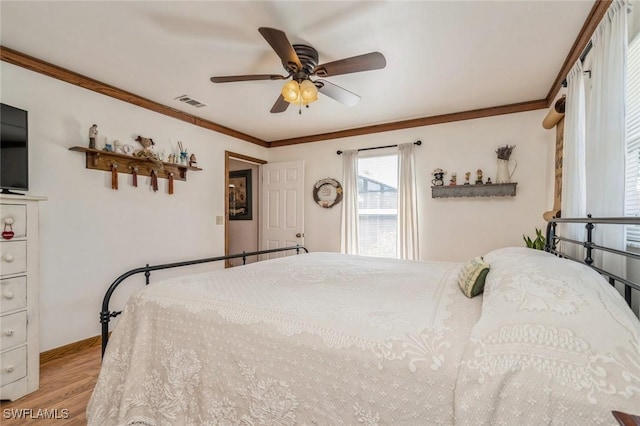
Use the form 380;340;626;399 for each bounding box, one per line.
545;215;640;315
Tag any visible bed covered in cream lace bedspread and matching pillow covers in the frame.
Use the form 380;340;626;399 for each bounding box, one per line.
87;218;640;425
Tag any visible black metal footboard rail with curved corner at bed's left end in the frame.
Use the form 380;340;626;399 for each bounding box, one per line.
100;245;309;357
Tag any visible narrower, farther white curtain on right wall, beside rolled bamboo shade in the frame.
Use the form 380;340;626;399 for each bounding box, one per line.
559;60;587;259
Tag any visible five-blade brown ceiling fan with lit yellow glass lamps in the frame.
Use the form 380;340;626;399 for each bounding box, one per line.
211;27;387;113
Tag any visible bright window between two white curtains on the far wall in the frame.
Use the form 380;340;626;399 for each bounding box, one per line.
358;154;398;257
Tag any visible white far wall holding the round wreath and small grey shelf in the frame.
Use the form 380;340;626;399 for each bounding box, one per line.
269;110;555;260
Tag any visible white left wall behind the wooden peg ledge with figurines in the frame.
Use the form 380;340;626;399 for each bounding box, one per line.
0;62;266;351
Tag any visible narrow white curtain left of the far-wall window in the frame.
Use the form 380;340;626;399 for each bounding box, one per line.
341;150;358;254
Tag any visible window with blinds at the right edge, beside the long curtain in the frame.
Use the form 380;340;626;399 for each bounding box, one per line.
624;32;640;247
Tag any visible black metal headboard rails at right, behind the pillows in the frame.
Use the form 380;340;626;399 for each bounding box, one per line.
545;215;640;315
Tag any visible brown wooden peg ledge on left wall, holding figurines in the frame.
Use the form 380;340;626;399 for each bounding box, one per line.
69;146;202;180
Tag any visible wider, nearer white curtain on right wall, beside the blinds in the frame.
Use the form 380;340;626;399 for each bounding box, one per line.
585;0;627;276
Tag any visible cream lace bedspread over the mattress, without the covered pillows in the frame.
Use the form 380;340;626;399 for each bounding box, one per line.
87;253;482;425
